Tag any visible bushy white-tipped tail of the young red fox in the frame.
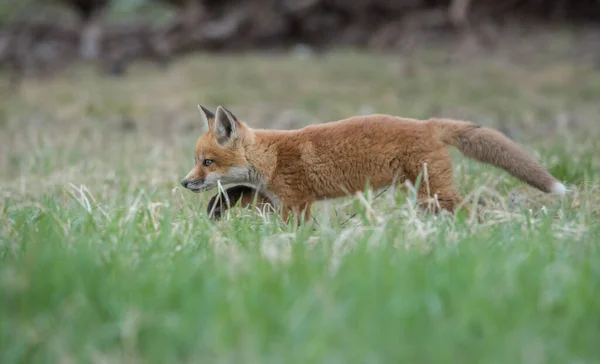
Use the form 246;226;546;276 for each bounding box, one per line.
430;119;568;195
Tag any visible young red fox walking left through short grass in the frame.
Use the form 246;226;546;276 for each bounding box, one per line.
181;105;568;224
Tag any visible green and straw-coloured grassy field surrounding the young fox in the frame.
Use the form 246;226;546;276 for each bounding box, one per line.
0;46;600;364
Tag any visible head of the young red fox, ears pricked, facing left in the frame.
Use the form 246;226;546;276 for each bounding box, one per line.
181;105;251;193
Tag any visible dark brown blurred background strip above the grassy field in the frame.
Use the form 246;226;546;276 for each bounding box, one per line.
0;0;600;80
